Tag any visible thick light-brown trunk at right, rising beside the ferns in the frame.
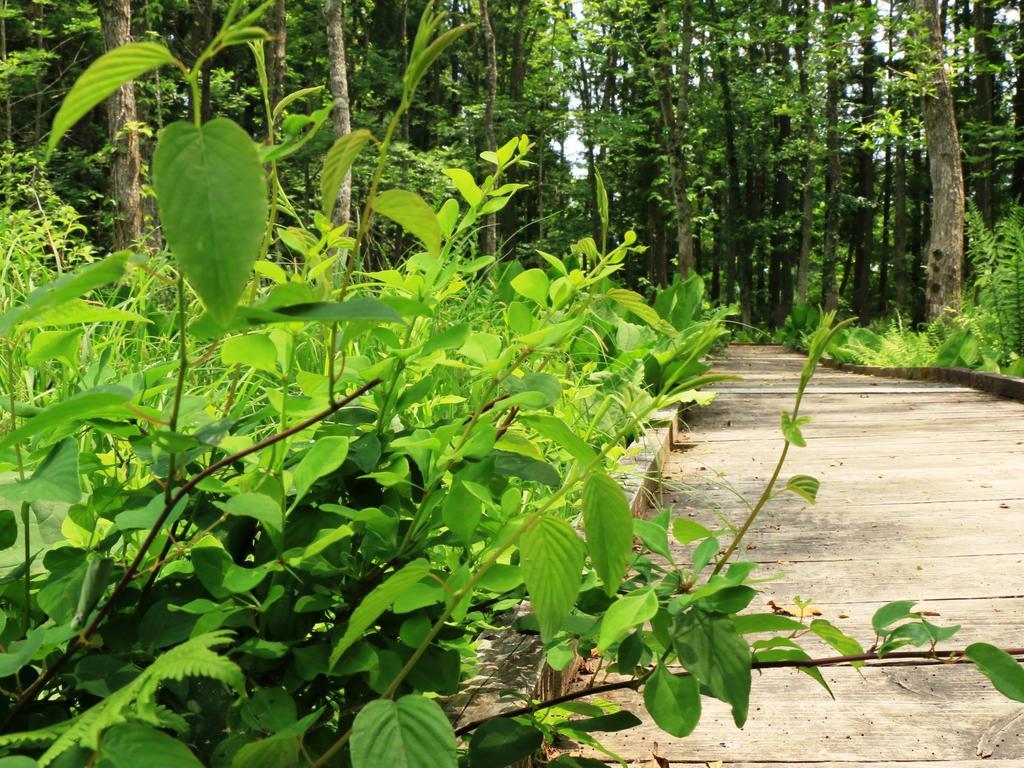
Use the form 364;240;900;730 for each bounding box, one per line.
916;0;964;321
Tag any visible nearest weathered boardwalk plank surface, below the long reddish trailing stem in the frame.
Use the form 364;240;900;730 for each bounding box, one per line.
574;665;1024;765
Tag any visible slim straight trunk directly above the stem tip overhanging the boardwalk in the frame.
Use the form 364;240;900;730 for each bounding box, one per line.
821;0;843;310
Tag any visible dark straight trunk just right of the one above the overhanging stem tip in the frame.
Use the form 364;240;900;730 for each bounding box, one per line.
853;0;878;326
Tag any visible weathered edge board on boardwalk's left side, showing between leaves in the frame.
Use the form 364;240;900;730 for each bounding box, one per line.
444;411;679;728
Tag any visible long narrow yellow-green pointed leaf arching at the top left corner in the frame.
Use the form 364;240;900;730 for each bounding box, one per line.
46;43;174;155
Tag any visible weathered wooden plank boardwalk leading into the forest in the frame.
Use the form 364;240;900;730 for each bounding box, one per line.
587;346;1024;768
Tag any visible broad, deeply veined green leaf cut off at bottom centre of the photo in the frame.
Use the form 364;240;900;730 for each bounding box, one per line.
351;695;457;768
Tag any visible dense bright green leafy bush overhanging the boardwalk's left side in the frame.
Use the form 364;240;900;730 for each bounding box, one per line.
0;2;1024;768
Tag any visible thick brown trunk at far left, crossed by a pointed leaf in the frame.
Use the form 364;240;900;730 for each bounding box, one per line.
99;0;142;251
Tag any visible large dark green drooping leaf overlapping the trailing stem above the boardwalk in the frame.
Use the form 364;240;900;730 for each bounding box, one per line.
672;608;751;728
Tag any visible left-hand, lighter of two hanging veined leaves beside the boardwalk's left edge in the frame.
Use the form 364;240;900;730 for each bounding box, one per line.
519;516;584;642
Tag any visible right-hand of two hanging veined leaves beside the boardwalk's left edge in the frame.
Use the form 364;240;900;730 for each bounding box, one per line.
583;474;633;596
